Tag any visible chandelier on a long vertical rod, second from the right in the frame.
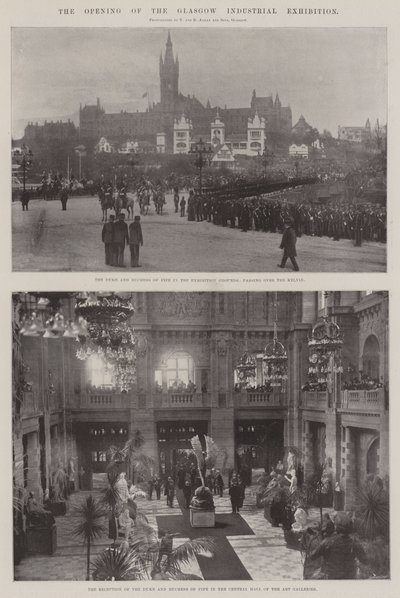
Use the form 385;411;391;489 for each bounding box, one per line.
262;293;288;391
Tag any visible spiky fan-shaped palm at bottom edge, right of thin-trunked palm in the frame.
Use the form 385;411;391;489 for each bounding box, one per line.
92;547;141;581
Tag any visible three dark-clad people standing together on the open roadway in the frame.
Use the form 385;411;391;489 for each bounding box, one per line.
101;212;143;268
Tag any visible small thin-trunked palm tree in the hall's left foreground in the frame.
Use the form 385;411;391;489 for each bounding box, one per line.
72;494;106;581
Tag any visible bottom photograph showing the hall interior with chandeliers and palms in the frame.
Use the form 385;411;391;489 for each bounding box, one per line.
9;291;390;583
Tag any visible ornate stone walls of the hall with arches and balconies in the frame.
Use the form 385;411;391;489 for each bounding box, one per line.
13;291;389;508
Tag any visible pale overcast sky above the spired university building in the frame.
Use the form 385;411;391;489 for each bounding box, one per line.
12;28;387;137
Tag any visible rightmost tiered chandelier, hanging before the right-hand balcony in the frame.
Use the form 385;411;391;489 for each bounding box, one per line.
308;316;343;391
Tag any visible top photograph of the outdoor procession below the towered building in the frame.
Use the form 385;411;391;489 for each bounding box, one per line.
10;27;388;274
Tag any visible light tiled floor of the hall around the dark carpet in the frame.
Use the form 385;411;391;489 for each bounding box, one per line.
15;482;316;581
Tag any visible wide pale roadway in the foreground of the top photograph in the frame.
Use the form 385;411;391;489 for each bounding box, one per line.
12;194;386;273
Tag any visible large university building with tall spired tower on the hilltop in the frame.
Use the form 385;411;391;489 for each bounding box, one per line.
79;33;292;153
